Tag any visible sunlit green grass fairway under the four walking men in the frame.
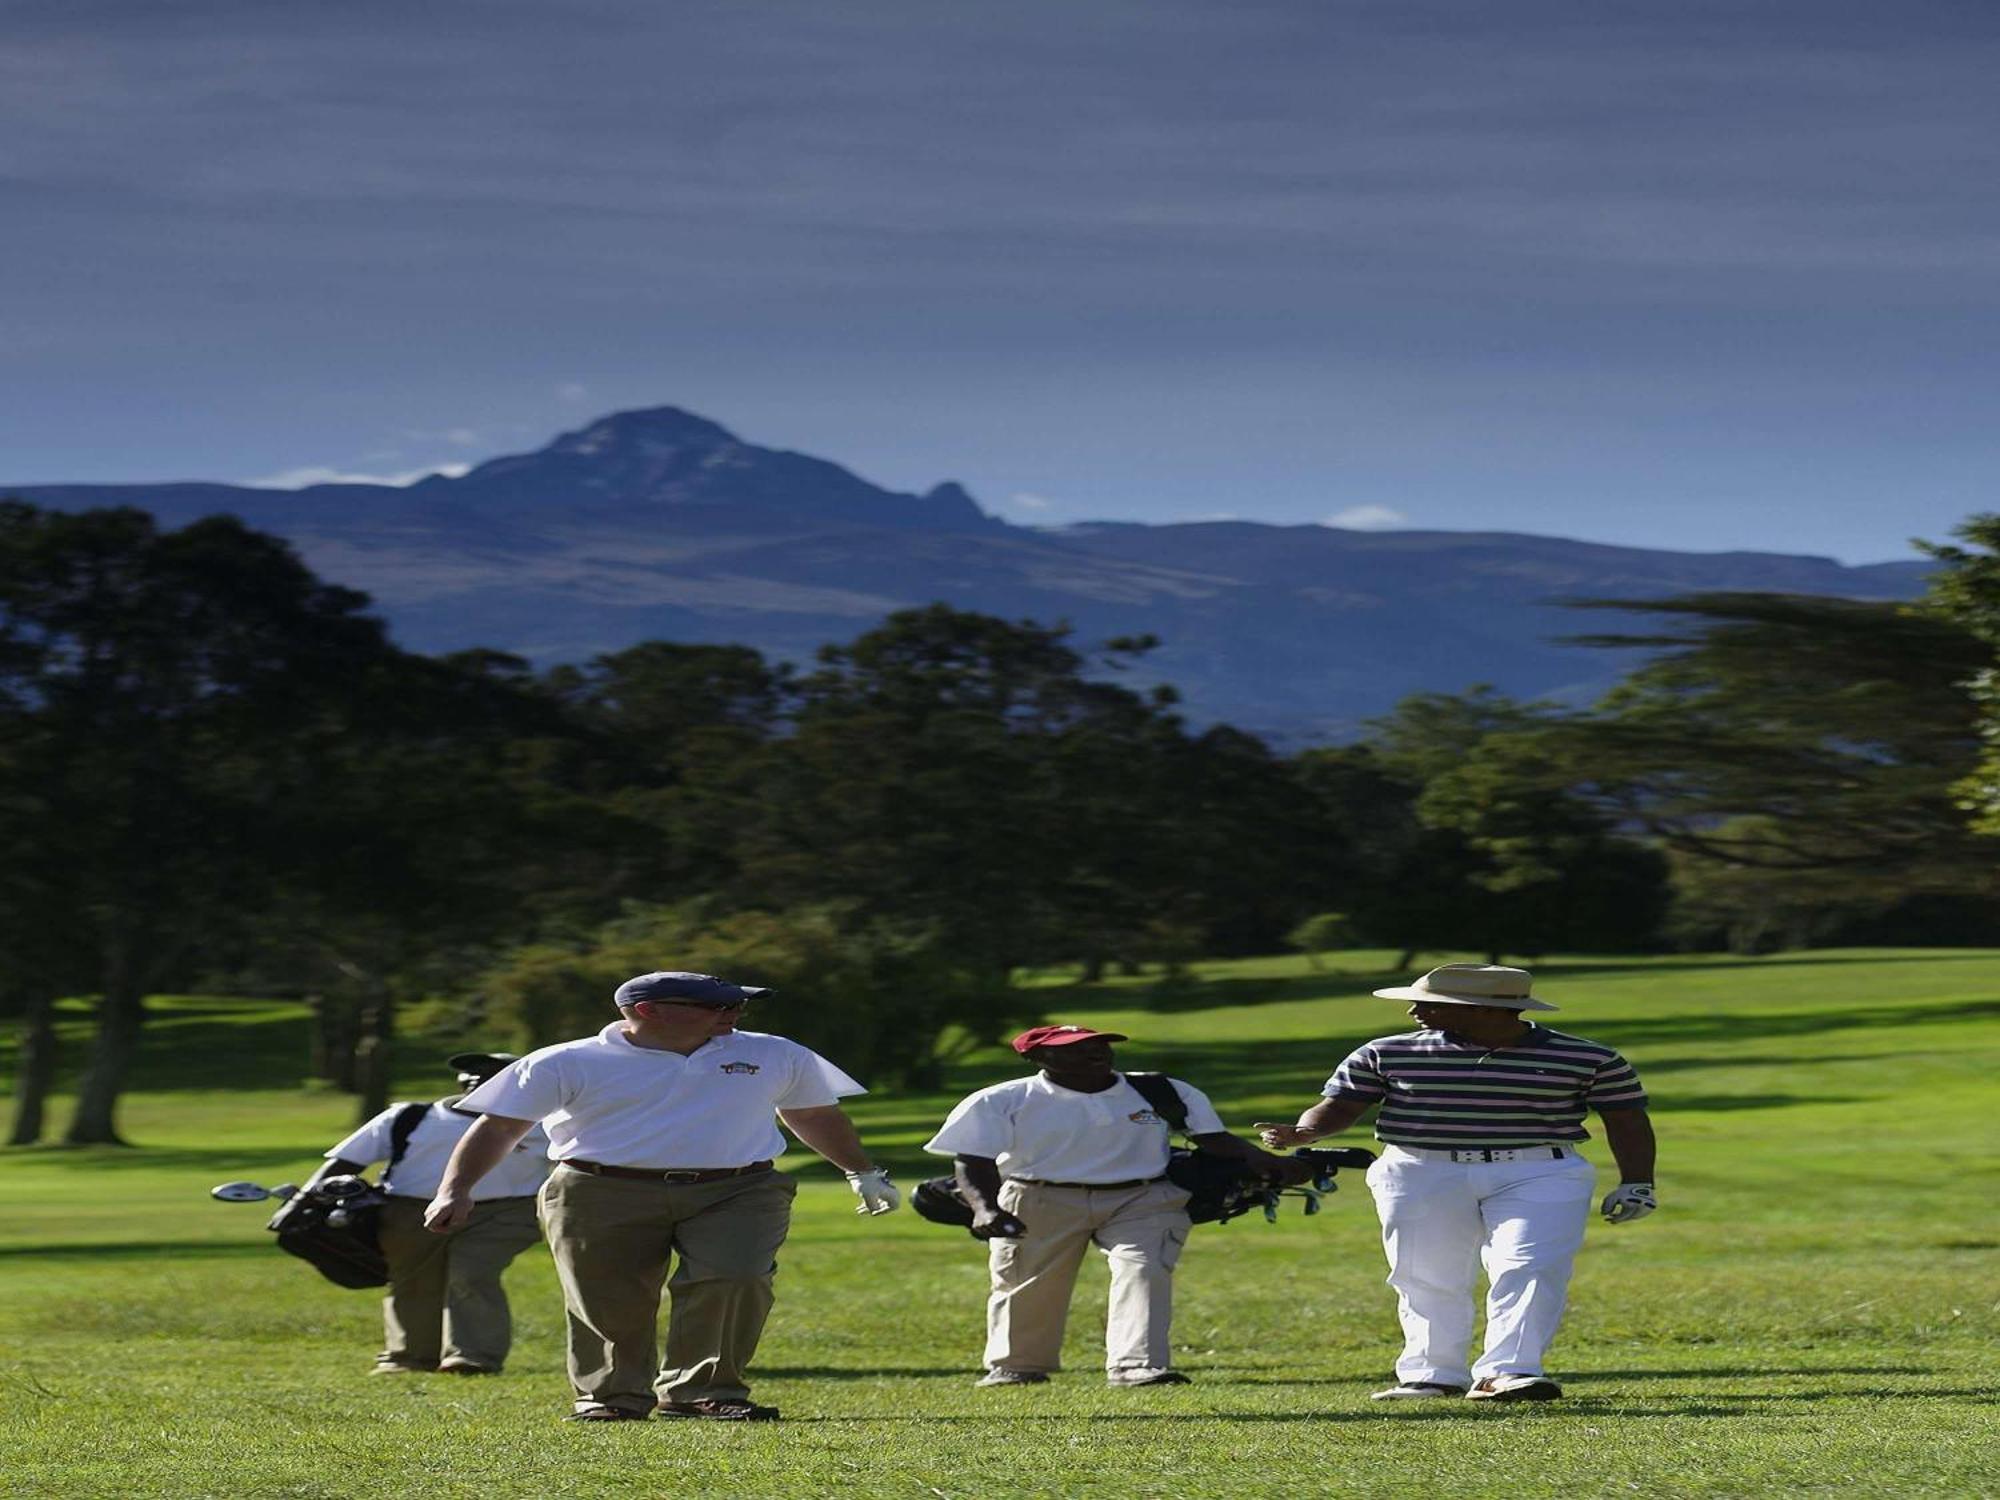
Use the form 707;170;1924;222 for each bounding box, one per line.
0;950;2000;1500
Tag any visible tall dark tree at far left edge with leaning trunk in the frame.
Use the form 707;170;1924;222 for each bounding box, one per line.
0;502;402;1144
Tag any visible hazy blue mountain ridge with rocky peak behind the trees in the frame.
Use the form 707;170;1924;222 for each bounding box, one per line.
0;406;1930;744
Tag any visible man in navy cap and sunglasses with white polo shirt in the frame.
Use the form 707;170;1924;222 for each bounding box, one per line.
428;970;900;1422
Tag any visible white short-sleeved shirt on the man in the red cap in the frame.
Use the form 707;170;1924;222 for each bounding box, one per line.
924;1074;1222;1182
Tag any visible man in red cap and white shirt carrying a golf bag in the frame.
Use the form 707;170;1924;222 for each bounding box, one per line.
924;1026;1296;1386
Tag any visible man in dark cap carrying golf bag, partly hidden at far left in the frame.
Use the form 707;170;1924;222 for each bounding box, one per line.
322;1052;548;1374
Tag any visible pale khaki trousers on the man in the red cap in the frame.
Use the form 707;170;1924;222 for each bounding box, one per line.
986;1180;1190;1378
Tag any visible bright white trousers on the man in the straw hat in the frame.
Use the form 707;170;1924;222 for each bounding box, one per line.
1368;1146;1596;1386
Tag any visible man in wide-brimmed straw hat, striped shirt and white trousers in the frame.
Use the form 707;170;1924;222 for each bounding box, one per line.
1258;964;1656;1402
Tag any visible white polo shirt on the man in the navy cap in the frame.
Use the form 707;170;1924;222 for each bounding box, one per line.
460;1020;868;1172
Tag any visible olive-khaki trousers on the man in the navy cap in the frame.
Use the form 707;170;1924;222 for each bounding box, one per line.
542;1166;798;1412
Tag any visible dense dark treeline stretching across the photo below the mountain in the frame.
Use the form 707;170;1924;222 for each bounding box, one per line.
0;502;2000;1144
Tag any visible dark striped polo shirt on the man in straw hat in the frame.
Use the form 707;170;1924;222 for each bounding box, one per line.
1320;1022;1646;1148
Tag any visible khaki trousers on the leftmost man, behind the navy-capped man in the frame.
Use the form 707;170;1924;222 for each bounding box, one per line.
376;1198;542;1370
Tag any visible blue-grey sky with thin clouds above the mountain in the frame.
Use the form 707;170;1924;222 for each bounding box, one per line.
0;0;2000;562
